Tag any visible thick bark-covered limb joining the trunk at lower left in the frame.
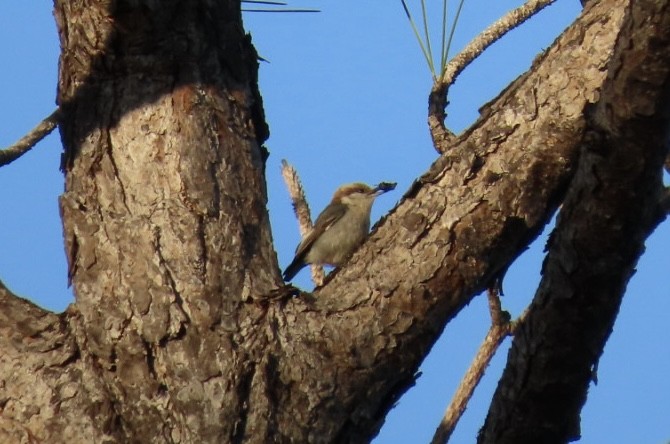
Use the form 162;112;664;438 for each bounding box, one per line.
0;282;114;442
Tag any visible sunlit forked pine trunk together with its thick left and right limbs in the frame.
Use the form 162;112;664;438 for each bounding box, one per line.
0;0;667;443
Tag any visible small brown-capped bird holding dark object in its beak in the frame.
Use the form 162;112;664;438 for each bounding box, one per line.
283;182;396;282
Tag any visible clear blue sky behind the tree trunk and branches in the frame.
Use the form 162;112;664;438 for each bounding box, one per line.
0;0;670;444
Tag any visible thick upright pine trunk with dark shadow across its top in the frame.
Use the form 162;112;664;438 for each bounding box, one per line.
3;0;281;443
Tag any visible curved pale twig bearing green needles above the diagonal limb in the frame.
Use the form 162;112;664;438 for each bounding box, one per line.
428;0;556;154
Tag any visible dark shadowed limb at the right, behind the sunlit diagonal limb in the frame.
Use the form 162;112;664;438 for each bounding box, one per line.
479;0;670;444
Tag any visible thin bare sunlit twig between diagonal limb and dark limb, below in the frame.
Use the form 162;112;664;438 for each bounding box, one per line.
431;288;527;444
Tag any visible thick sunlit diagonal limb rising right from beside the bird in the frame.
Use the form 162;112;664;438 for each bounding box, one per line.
276;0;626;442
